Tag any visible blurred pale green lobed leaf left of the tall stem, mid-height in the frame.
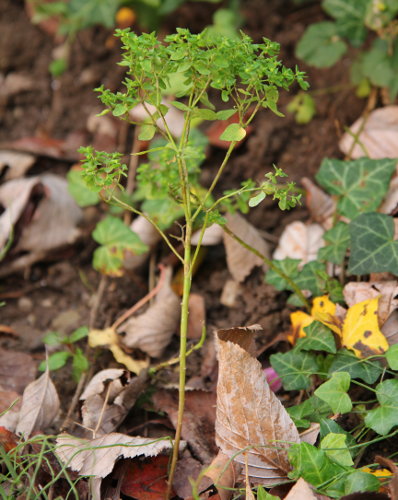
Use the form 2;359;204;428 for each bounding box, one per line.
92;216;148;276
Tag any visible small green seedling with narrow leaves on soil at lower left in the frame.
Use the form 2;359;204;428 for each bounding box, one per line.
39;326;89;382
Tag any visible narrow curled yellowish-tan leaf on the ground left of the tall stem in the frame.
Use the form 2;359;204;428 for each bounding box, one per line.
88;328;149;375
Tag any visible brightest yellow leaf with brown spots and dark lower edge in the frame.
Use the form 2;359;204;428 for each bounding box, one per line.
342;297;389;358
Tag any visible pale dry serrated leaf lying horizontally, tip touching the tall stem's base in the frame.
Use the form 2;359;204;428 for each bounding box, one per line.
56;432;180;477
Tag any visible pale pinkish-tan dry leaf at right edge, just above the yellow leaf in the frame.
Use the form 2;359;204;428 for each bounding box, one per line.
343;281;398;325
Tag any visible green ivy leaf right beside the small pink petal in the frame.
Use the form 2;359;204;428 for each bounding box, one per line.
270;350;318;391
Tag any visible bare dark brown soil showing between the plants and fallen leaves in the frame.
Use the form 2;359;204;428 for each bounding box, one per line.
0;0;378;496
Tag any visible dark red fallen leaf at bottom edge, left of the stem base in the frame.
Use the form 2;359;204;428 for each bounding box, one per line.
121;455;174;500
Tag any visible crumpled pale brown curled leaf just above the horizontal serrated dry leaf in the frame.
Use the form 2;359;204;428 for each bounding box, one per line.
80;368;147;436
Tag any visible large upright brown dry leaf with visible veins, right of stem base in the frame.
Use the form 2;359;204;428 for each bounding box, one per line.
216;328;300;485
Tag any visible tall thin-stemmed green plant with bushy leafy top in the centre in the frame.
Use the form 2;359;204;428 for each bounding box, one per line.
81;29;307;492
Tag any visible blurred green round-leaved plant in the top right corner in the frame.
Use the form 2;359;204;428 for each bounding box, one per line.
296;0;398;100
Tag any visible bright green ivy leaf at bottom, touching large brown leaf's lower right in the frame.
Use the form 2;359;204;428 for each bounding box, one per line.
288;443;345;487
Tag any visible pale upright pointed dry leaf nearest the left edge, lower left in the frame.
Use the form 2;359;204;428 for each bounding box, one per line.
16;370;60;437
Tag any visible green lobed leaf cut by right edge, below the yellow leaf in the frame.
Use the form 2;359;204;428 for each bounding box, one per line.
365;379;398;436
